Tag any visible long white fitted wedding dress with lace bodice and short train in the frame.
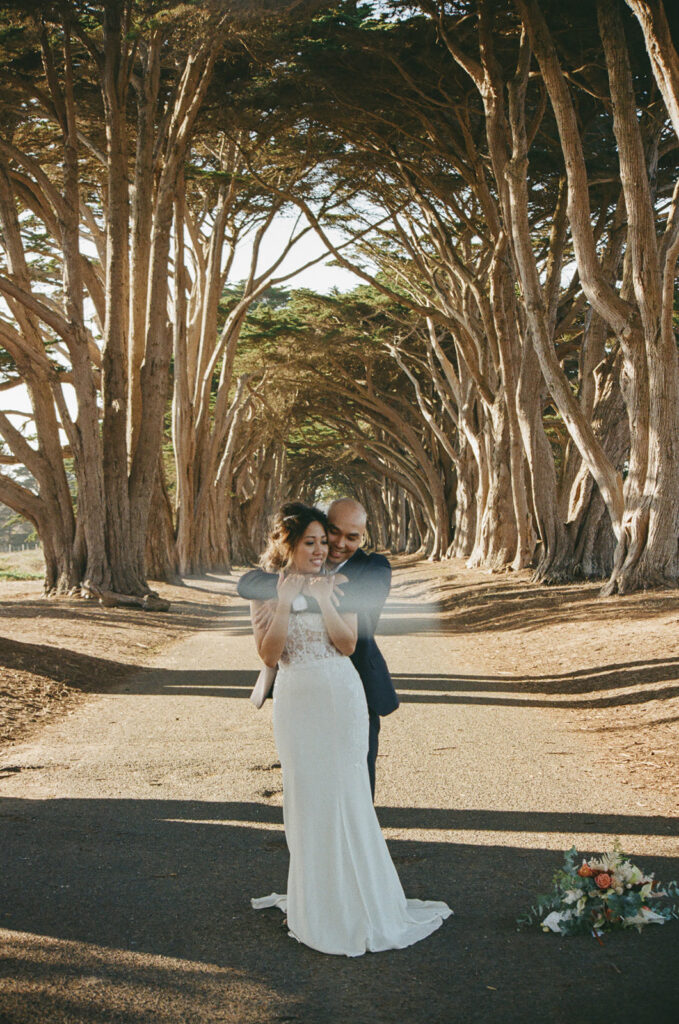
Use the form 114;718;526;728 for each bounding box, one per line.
252;611;453;956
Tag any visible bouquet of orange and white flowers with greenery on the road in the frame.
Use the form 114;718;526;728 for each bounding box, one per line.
517;845;679;938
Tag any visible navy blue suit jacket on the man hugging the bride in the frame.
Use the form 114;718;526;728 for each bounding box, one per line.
238;548;398;715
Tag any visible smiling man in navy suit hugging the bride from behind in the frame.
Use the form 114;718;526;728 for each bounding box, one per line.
238;498;398;799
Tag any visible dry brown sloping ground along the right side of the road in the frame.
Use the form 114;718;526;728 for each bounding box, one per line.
393;562;679;810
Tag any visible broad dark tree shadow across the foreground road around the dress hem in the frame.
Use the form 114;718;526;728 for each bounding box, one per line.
0;783;679;1024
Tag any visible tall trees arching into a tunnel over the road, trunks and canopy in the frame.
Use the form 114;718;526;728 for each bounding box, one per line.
0;0;679;598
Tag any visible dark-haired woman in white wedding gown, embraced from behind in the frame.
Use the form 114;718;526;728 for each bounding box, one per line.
251;502;452;956
